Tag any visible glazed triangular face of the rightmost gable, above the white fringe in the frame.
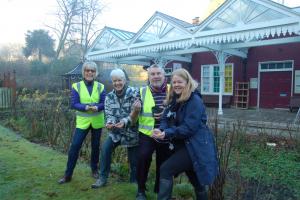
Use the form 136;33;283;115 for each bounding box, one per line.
197;0;298;31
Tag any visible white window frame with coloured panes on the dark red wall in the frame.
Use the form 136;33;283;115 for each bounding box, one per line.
201;63;234;95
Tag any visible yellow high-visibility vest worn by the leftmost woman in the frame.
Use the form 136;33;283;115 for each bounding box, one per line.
72;81;104;129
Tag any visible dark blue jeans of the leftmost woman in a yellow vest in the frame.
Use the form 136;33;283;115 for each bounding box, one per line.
65;127;102;177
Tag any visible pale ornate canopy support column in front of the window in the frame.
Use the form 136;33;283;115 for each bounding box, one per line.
214;51;231;115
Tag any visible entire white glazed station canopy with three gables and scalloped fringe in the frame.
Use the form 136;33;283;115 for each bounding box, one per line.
86;0;300;65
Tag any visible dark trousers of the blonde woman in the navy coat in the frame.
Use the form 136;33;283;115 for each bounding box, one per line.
160;145;205;191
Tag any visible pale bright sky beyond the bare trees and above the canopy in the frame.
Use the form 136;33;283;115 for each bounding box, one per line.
0;0;300;45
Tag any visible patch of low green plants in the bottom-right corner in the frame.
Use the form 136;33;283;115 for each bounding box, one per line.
230;142;300;199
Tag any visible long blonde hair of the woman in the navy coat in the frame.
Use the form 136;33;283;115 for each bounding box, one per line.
165;68;198;104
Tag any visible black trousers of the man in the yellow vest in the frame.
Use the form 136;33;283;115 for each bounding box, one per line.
137;133;171;193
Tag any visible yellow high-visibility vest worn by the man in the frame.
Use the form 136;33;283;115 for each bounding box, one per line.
139;85;170;135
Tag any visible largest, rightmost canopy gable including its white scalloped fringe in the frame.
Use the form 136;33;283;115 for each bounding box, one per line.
191;0;300;44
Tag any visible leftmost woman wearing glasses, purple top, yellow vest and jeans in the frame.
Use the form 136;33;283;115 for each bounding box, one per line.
58;61;106;184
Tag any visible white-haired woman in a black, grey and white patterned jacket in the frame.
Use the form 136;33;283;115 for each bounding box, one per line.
92;69;141;188
